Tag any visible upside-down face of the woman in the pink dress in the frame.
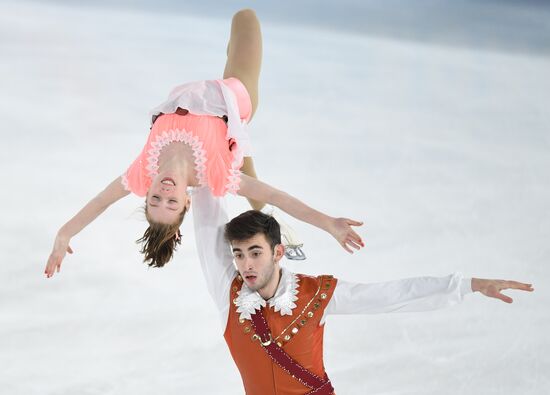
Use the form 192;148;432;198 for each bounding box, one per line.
145;176;191;224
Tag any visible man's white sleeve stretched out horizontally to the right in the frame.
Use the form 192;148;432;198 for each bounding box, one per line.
321;273;472;323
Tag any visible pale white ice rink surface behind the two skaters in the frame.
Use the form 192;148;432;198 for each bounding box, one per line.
0;2;550;395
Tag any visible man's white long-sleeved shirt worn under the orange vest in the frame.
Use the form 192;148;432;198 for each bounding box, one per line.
193;188;472;329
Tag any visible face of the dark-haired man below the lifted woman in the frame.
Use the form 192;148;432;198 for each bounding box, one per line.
231;233;284;291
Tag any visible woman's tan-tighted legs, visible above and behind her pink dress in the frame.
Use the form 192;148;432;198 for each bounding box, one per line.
223;9;265;210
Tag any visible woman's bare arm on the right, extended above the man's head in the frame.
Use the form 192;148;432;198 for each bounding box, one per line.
238;174;365;253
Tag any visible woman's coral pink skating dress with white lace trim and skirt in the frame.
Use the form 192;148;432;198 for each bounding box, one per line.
122;78;252;197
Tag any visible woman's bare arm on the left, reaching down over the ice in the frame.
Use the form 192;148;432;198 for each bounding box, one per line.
44;177;130;278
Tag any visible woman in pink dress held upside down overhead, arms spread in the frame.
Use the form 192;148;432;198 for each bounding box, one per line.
45;10;364;278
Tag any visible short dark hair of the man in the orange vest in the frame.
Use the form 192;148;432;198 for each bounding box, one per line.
224;210;281;249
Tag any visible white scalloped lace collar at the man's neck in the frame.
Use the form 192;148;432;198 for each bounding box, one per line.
235;267;300;320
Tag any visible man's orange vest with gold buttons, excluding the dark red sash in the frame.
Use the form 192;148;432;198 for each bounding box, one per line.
224;274;337;395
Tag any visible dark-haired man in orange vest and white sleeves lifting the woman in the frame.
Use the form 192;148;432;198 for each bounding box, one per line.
193;188;533;395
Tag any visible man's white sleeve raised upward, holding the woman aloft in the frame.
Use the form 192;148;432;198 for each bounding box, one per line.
192;187;235;329
